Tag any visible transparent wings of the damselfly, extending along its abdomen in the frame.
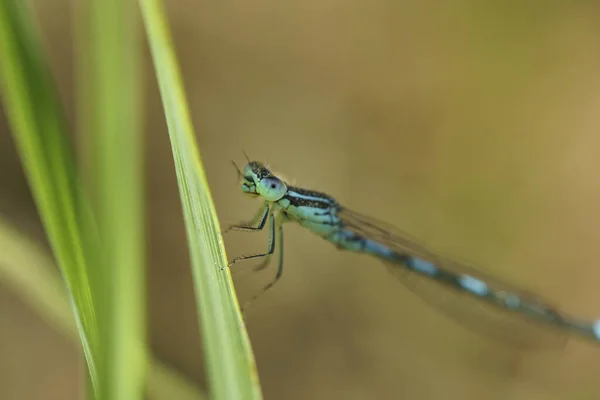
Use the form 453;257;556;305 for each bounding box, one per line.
337;209;600;349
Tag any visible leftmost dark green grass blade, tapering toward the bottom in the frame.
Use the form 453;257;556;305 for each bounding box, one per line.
0;1;98;386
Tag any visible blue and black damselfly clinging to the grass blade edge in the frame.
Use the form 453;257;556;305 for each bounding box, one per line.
228;161;600;343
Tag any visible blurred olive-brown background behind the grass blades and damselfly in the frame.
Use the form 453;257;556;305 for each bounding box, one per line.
0;0;600;400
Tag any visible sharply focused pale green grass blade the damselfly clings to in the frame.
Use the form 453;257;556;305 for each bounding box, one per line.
139;0;262;400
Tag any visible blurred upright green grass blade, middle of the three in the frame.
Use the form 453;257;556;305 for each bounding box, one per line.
76;0;147;400
